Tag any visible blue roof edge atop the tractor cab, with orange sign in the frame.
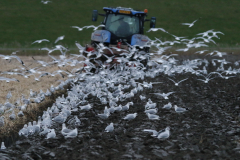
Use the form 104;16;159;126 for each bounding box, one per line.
103;7;146;15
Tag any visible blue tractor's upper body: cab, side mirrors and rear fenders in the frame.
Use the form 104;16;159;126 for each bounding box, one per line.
91;7;156;45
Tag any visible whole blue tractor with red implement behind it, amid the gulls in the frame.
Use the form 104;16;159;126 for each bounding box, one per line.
85;7;156;70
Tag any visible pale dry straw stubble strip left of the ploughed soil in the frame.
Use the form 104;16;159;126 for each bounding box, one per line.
0;56;82;138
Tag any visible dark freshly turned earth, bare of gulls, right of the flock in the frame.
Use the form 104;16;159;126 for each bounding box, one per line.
0;56;240;160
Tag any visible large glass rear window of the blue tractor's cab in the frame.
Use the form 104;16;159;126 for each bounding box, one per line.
105;14;139;37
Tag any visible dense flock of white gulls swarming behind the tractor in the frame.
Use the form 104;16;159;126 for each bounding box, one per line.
0;26;240;149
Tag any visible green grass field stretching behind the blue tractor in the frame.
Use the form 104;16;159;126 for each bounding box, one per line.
0;0;240;50
